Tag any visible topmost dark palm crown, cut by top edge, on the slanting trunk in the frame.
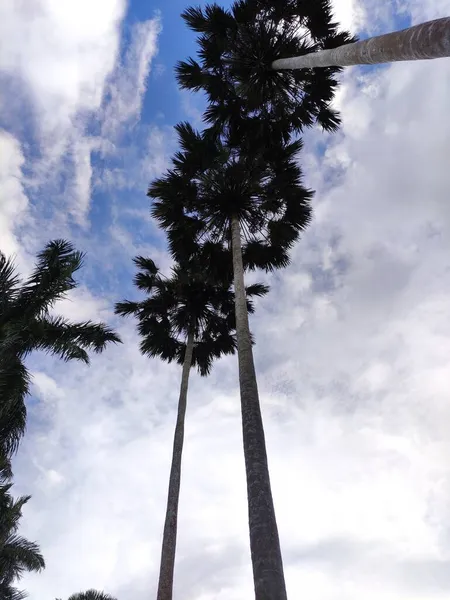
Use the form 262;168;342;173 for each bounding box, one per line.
176;0;355;144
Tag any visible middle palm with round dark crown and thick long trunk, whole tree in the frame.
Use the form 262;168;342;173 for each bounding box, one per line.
148;123;312;600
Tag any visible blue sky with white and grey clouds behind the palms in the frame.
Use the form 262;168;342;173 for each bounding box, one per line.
0;0;450;600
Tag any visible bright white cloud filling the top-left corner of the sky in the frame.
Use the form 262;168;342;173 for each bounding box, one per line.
0;0;125;135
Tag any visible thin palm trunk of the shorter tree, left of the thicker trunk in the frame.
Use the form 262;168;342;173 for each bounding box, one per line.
157;331;194;600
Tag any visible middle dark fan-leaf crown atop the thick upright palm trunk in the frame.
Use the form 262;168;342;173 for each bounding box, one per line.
148;123;312;278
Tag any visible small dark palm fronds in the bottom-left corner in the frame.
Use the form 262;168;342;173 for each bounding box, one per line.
0;476;45;600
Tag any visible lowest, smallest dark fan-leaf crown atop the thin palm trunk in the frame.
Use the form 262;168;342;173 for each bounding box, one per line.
116;255;268;375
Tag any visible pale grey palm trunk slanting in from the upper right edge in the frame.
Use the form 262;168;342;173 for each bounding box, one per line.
272;17;450;70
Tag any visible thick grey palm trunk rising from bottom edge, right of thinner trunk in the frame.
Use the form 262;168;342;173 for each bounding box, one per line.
231;217;287;600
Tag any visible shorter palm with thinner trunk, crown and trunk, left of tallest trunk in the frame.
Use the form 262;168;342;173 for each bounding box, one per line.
116;257;268;600
